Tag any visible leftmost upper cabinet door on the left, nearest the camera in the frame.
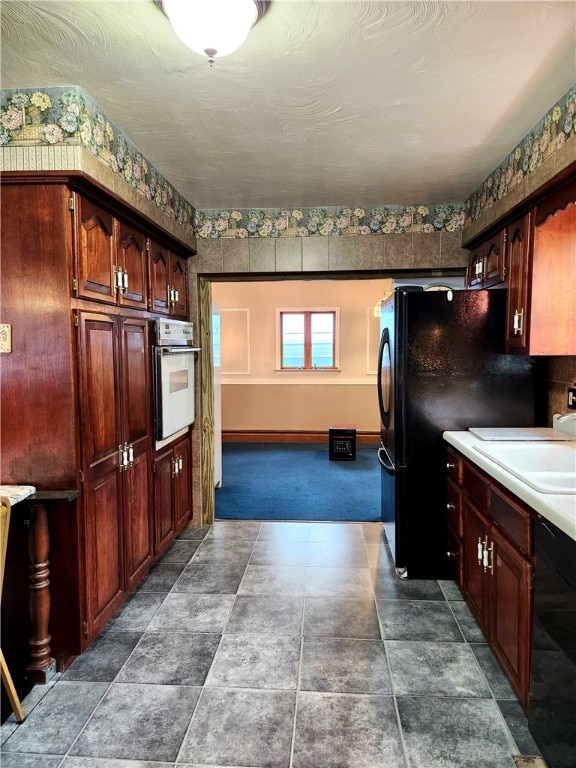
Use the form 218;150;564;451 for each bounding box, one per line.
74;195;116;304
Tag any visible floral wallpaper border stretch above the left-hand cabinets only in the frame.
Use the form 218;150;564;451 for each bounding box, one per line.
0;86;194;232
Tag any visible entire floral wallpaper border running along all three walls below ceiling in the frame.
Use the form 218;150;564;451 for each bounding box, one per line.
0;84;576;239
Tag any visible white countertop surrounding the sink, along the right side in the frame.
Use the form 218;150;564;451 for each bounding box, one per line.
443;432;576;541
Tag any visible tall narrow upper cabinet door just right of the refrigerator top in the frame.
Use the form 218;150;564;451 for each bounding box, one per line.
506;214;532;352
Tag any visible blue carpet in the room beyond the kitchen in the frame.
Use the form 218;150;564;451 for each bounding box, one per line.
216;443;381;522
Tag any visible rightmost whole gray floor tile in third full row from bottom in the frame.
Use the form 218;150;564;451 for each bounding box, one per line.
376;600;464;643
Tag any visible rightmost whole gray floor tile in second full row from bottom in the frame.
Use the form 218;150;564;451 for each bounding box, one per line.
385;640;490;697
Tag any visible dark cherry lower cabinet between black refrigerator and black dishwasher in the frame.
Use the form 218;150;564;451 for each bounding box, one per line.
448;449;533;709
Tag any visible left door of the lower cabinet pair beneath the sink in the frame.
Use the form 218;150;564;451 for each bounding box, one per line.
463;497;490;636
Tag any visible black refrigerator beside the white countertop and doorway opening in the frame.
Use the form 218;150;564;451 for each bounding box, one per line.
378;286;537;579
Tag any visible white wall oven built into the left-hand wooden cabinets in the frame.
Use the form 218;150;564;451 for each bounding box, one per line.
153;320;199;440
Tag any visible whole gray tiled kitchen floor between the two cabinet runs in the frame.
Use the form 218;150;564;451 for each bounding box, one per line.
1;521;538;768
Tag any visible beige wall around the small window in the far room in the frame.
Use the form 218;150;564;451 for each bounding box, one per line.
212;278;391;432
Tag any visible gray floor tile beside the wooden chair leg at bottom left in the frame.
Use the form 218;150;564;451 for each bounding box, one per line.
2;680;108;755
